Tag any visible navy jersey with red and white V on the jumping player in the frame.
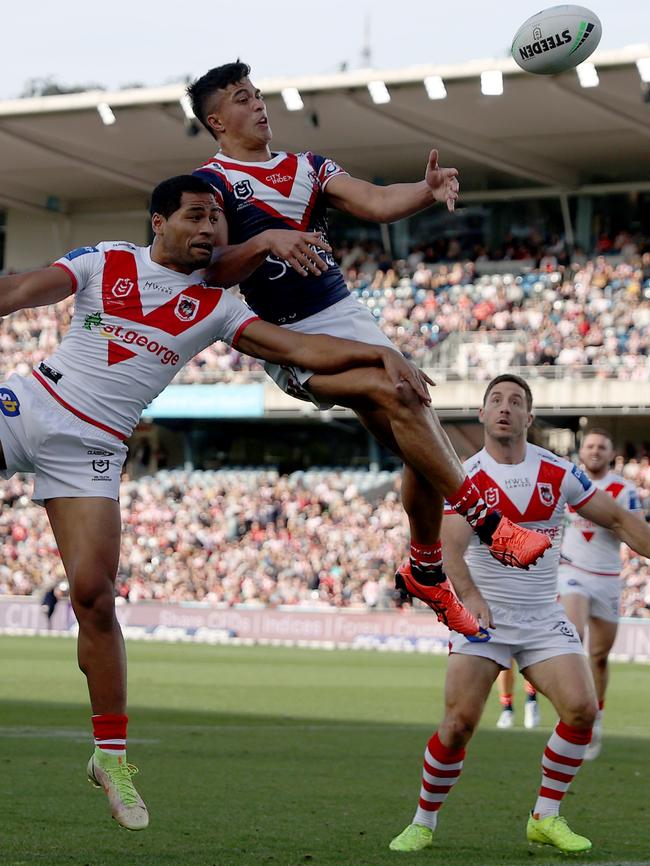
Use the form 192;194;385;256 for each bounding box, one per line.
194;151;348;325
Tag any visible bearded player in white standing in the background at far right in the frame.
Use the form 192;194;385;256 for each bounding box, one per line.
558;428;644;760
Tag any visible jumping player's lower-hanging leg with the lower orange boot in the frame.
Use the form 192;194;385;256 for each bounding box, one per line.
340;400;480;635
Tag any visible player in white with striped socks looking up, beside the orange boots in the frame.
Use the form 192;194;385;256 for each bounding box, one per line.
390;375;650;853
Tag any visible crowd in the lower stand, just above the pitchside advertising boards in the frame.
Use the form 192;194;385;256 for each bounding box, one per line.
0;466;650;617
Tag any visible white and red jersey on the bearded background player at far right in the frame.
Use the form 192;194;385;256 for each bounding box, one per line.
562;472;643;577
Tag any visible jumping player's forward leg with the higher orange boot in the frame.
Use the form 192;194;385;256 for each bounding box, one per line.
308;367;550;568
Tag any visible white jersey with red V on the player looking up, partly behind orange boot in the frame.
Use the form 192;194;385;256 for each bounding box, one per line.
445;443;596;605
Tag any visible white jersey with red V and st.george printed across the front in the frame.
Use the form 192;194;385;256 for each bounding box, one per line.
33;241;257;439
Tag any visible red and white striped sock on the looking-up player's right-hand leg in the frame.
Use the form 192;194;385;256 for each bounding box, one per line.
533;721;591;818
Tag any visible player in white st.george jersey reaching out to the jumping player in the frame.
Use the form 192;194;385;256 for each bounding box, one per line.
0;175;436;830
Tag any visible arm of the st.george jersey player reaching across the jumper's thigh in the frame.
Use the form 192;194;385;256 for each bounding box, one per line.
237;319;433;405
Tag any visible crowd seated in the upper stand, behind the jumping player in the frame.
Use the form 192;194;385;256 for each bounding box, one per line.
0;240;650;383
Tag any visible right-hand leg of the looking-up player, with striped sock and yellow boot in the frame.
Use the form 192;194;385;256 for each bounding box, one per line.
524;653;598;853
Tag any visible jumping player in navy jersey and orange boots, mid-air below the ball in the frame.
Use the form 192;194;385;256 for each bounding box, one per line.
188;61;549;634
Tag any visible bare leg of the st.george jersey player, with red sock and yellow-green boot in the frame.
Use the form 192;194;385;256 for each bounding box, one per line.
45;497;149;830
